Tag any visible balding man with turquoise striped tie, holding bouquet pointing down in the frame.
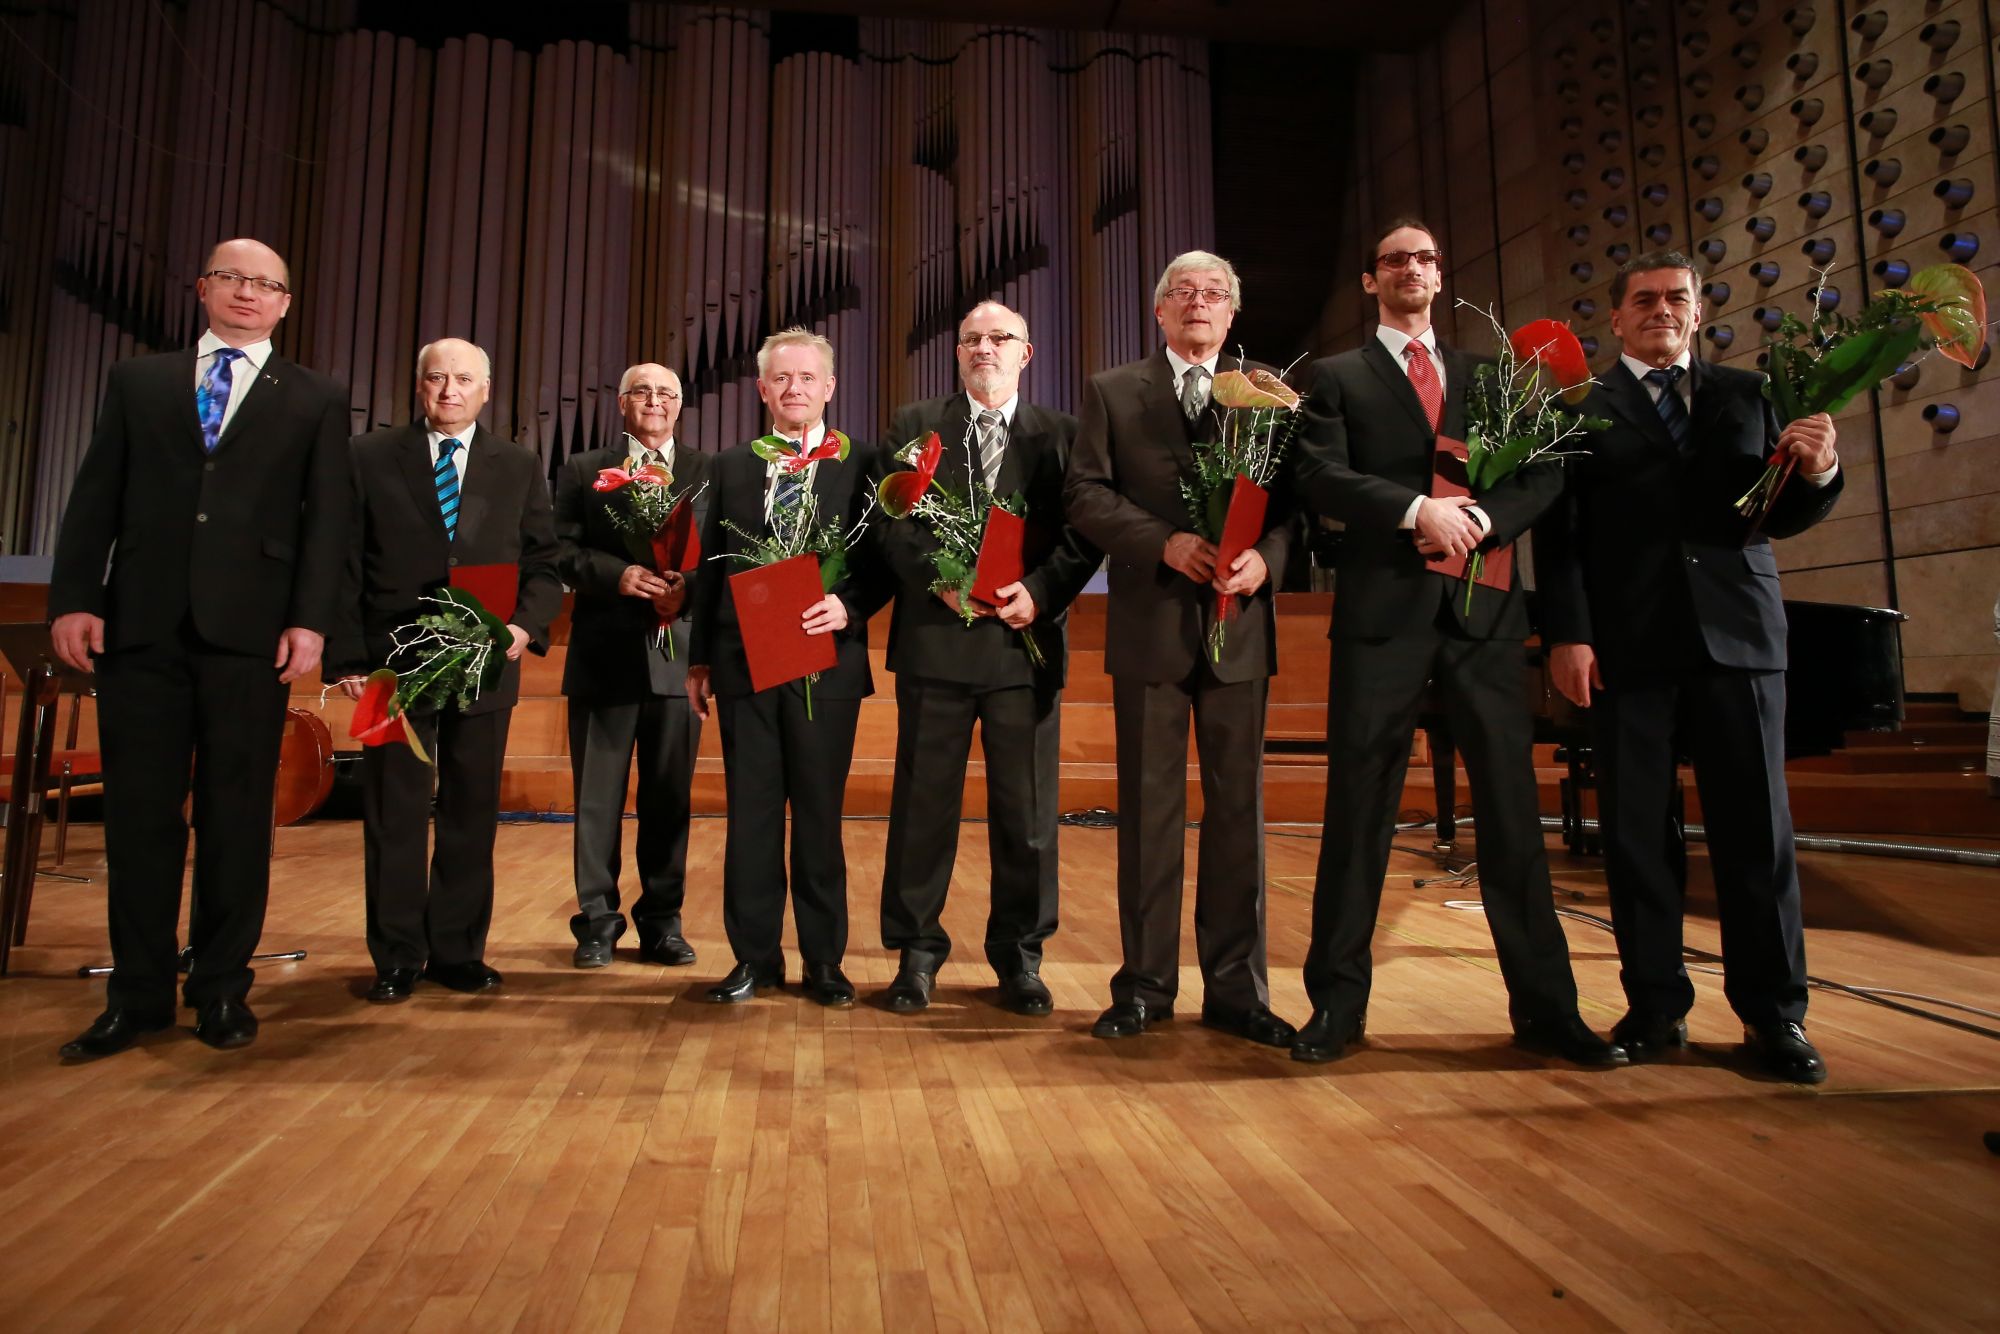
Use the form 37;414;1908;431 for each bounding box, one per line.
332;338;562;1004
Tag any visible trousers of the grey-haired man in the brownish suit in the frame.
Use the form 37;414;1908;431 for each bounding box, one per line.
1112;662;1270;1010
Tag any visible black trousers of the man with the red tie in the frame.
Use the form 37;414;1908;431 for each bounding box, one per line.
1306;628;1576;1030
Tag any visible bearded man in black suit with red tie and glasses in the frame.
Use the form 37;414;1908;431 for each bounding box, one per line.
1292;218;1624;1066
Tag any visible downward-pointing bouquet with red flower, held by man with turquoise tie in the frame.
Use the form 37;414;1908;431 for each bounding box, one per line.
348;588;514;764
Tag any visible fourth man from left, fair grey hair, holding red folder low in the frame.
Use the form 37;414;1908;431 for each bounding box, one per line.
688;328;888;1008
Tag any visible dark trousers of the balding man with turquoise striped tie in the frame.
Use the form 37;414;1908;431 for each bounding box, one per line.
362;708;514;970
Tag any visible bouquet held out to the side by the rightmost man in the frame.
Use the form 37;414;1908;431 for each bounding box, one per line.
1736;264;1986;536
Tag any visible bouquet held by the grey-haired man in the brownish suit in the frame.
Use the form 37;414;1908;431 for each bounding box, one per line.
1180;352;1298;662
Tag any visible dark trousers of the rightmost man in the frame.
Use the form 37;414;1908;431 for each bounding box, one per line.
1590;664;1806;1024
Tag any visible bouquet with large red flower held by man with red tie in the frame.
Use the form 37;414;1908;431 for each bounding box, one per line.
1458;302;1610;612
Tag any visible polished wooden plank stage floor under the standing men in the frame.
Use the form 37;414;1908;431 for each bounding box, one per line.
0;820;2000;1334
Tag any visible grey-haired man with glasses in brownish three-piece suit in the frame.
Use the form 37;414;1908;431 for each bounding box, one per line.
1064;250;1294;1046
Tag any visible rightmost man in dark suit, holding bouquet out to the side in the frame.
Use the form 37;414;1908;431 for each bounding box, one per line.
1534;252;1842;1084
